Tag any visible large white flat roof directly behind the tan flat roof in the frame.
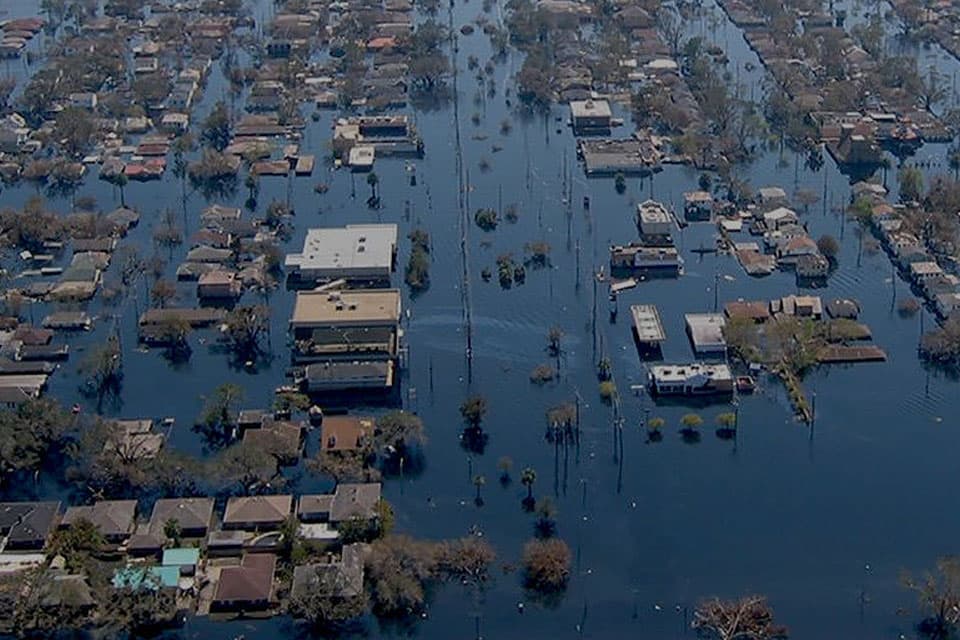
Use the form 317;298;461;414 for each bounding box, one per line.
284;224;397;272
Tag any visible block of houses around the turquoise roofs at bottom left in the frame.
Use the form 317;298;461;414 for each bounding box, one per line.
0;484;380;614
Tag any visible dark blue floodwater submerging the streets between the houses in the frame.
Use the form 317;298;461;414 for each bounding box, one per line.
0;2;960;639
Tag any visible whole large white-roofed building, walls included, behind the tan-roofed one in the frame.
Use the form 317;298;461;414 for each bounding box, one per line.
284;224;397;283
